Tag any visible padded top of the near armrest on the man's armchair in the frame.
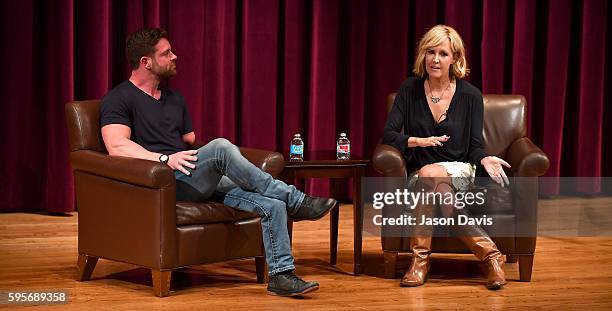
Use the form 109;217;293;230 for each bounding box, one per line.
70;150;175;189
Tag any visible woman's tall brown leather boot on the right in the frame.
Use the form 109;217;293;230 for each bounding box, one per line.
455;212;506;290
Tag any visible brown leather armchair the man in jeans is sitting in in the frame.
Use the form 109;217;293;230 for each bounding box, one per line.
66;100;284;297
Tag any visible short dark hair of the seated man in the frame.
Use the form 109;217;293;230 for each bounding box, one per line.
125;28;168;69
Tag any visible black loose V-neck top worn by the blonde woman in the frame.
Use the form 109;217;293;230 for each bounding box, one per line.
383;77;487;171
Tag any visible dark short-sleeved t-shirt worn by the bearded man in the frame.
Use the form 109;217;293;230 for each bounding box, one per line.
100;80;193;154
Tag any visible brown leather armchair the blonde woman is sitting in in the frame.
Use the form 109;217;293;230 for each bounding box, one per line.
372;93;549;281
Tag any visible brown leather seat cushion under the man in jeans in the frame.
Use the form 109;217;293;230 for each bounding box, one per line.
176;201;259;226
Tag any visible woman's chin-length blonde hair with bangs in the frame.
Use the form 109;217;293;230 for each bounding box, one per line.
412;25;470;78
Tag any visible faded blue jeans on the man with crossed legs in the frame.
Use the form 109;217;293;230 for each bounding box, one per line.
174;138;304;275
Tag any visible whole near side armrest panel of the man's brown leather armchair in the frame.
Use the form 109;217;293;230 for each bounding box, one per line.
70;150;177;269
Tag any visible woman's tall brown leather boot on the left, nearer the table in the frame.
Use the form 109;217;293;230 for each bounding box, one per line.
400;182;435;287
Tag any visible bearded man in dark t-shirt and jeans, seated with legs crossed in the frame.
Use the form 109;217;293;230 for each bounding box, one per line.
100;28;336;296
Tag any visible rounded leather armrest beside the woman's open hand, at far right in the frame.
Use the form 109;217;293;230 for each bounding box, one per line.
506;137;550;177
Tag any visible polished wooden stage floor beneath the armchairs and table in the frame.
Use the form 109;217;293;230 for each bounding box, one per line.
0;200;612;310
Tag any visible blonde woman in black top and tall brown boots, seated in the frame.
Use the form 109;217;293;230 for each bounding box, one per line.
383;25;510;289
